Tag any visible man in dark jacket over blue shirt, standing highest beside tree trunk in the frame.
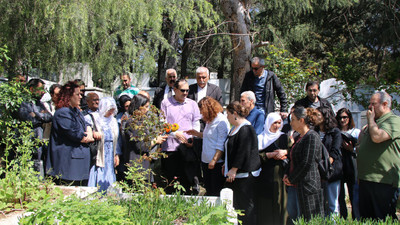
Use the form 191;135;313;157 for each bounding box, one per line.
240;57;288;119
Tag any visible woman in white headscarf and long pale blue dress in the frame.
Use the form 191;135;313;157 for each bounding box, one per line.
85;97;121;191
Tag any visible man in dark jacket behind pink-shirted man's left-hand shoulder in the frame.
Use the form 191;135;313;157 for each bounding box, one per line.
153;69;177;109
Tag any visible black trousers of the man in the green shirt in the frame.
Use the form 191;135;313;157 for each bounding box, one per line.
359;180;399;220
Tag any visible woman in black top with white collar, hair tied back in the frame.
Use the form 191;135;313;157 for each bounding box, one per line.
223;101;261;224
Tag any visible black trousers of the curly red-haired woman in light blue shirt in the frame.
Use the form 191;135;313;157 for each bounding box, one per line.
201;162;225;196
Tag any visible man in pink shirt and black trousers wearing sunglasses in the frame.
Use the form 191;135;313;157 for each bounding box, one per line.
161;79;201;194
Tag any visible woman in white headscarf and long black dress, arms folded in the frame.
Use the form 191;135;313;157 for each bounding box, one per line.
256;112;288;224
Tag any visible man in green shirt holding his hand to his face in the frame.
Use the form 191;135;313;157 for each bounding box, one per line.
357;91;400;220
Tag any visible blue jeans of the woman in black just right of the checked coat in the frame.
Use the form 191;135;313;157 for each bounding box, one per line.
325;180;340;216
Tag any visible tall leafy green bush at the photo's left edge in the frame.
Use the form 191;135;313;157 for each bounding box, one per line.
0;82;61;211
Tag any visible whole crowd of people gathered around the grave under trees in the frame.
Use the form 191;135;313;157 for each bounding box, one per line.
15;57;400;224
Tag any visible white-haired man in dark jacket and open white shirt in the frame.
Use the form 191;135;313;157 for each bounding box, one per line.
188;67;223;105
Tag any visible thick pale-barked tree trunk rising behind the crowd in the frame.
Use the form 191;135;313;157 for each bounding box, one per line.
221;0;251;101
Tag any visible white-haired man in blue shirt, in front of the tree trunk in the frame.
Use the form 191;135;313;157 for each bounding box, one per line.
240;91;265;135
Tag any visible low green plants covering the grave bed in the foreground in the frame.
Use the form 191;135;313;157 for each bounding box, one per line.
20;194;229;225
